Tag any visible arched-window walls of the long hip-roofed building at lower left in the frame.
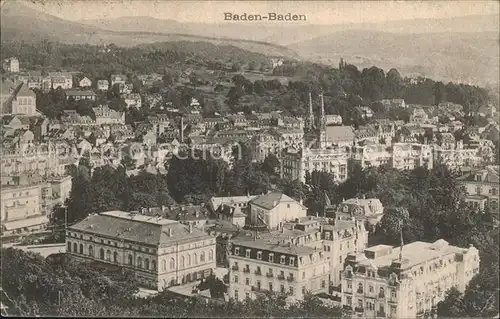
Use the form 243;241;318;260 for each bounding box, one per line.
66;229;216;290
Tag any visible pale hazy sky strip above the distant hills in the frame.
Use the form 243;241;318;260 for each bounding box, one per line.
21;0;500;25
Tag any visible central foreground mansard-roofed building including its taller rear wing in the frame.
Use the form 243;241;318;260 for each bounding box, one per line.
229;216;368;299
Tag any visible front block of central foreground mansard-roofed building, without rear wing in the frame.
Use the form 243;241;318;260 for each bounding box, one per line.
229;231;330;300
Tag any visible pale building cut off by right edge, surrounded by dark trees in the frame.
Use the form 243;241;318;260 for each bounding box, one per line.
458;166;500;213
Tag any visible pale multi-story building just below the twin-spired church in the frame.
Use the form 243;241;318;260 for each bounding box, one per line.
281;148;350;182
